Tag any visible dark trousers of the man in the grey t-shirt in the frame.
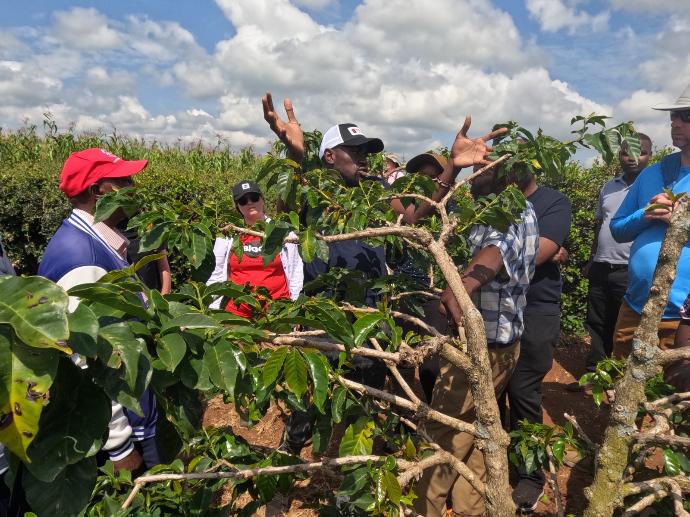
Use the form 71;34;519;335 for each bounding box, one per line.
585;262;628;372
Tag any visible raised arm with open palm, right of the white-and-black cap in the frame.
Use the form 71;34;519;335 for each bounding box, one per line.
391;116;507;224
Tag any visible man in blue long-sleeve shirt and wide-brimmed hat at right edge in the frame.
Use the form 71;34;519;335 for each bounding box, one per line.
610;86;690;376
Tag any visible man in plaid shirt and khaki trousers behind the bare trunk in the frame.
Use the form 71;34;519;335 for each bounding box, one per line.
414;163;540;517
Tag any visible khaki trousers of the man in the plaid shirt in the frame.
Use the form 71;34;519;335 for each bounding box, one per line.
415;340;520;517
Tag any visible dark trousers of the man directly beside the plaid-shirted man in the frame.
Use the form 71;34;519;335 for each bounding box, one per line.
501;306;561;484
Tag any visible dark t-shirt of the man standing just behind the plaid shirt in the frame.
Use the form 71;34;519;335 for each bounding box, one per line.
526;187;572;315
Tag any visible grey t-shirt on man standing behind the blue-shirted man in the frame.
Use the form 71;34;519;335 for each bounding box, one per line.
594;176;632;264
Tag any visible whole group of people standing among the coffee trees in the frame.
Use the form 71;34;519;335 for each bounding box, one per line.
0;82;690;516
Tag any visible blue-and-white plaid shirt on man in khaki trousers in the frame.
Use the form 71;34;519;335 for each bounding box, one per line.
469;201;539;347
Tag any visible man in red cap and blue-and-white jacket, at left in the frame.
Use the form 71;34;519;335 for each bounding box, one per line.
38;148;160;470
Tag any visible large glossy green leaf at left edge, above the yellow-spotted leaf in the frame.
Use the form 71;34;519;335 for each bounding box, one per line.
0;276;72;354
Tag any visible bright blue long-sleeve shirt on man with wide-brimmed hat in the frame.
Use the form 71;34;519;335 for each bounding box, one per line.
609;153;690;319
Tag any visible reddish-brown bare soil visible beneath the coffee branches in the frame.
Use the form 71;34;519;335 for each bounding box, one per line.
204;336;608;517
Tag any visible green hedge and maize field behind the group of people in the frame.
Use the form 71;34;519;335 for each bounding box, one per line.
0;122;667;333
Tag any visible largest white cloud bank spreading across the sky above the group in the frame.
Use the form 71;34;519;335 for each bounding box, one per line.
0;0;648;156
